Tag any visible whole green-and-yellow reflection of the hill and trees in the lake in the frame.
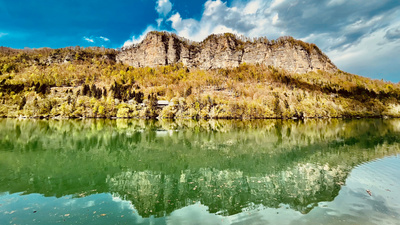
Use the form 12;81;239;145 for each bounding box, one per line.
0;119;400;223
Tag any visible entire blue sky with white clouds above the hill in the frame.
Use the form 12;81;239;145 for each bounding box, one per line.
0;0;400;83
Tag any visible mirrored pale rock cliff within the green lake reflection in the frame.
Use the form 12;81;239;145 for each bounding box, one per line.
107;164;348;216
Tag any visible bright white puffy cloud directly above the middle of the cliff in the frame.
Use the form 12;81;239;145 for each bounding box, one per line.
162;0;280;41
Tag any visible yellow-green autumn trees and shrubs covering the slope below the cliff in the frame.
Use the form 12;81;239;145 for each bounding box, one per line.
0;47;400;119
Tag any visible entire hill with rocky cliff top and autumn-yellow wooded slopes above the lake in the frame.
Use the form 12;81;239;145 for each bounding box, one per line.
0;32;400;119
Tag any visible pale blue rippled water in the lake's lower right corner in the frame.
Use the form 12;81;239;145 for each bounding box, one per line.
329;155;400;224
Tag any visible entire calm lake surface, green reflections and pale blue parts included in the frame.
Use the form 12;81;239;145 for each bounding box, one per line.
0;119;400;225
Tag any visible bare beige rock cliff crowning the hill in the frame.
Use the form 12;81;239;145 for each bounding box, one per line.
116;32;337;73
